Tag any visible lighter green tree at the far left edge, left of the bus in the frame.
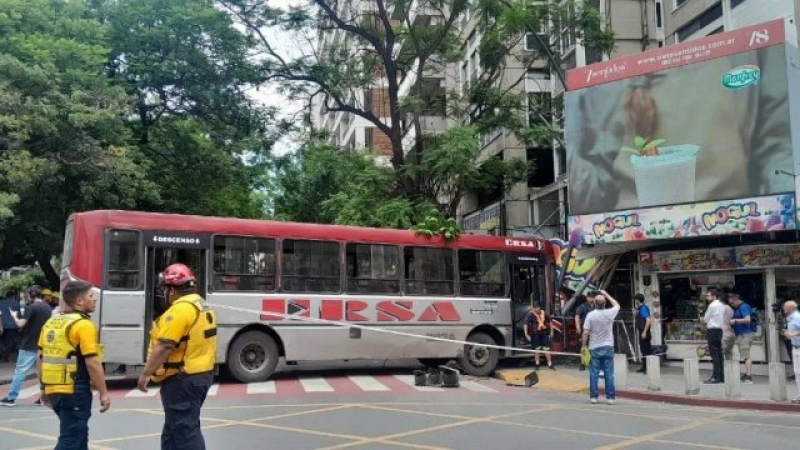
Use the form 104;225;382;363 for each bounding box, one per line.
0;0;154;285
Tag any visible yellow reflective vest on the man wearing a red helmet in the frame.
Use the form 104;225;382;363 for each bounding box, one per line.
150;294;217;383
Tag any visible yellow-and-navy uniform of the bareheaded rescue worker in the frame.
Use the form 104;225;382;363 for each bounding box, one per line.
38;312;102;449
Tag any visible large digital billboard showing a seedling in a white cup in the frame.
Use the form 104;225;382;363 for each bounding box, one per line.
565;20;798;217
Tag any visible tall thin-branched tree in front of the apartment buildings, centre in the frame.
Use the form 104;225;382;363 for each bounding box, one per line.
219;0;613;217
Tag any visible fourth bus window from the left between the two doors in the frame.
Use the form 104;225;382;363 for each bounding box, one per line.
405;247;455;295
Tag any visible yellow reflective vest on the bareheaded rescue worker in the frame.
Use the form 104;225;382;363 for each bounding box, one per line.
39;312;101;394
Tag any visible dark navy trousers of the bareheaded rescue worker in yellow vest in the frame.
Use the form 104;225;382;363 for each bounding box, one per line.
49;384;92;450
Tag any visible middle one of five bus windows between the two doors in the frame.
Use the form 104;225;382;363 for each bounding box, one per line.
345;244;400;294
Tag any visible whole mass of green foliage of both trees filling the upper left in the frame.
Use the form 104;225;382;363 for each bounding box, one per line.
0;0;282;284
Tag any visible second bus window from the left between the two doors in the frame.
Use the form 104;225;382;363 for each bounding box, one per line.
281;239;341;292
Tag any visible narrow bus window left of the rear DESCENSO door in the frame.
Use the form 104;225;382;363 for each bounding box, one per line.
106;230;141;289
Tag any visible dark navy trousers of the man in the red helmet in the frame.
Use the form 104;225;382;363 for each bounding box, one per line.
161;372;214;450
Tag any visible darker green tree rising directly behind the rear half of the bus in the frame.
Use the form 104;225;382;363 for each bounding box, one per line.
97;0;286;217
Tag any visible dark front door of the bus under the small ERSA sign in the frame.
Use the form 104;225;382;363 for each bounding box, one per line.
509;255;547;348
